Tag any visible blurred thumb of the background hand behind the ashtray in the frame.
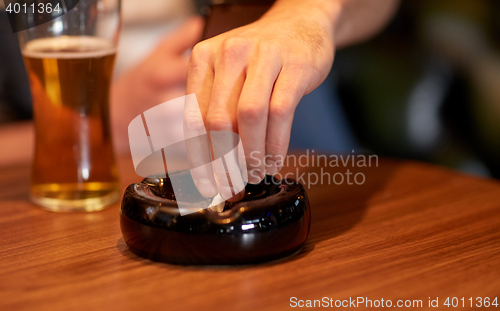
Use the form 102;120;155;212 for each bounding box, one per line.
160;16;204;54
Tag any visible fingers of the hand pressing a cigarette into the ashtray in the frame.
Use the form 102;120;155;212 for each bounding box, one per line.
185;38;308;200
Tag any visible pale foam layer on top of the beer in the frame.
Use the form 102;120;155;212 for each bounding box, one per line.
22;36;116;58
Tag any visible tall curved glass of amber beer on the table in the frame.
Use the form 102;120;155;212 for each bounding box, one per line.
19;0;121;212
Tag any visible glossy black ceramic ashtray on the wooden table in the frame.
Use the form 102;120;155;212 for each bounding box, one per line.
120;173;311;265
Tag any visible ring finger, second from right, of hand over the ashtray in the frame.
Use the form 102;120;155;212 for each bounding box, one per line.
237;47;281;184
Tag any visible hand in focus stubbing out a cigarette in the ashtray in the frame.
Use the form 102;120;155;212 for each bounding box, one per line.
184;4;334;200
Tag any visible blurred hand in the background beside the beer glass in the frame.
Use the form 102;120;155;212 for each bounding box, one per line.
111;17;203;153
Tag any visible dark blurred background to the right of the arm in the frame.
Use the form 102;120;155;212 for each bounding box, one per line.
334;0;500;178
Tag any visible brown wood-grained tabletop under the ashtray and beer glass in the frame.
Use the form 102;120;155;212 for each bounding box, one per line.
0;155;500;311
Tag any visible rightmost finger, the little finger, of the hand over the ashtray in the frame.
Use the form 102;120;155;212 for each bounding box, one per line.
265;70;305;175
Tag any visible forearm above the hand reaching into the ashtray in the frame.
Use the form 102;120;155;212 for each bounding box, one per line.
266;0;399;48
